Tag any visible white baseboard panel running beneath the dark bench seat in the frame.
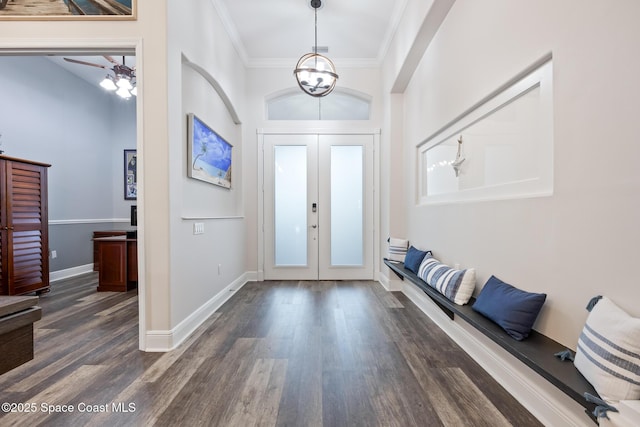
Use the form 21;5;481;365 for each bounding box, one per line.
402;282;593;427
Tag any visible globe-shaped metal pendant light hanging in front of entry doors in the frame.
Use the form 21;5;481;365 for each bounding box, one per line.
293;0;338;97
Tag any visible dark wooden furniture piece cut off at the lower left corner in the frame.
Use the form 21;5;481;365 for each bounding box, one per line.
0;296;42;375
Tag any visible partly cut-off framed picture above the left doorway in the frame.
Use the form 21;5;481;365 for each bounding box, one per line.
0;0;138;21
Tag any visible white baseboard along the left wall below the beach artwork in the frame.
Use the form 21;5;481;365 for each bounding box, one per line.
143;272;253;352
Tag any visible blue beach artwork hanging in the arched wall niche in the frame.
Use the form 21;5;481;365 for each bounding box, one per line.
187;113;233;188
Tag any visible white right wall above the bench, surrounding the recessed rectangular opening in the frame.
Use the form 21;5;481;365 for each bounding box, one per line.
398;0;640;348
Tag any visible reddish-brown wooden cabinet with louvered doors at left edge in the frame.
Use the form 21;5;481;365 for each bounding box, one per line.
0;156;51;295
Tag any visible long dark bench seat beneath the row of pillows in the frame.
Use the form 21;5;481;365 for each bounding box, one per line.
384;259;598;422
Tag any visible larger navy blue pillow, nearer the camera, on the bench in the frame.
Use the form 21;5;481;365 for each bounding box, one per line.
473;276;547;341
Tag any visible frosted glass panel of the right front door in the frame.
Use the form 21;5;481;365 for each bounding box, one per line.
331;146;364;266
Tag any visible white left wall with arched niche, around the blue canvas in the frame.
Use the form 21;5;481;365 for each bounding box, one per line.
168;0;246;340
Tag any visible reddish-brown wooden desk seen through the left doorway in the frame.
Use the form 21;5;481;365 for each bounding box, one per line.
93;236;138;292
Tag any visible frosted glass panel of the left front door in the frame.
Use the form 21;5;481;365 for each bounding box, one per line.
274;145;307;266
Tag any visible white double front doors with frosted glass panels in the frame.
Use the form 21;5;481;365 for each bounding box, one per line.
263;134;373;280
